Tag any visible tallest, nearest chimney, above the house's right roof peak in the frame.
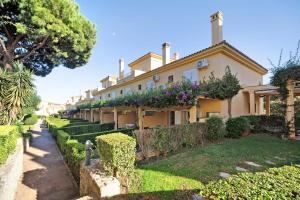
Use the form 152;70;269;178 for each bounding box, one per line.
210;11;223;45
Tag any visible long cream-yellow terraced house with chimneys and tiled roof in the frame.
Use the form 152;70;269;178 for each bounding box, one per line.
74;11;269;129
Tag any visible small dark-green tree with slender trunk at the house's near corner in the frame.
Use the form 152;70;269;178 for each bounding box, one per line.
200;66;241;118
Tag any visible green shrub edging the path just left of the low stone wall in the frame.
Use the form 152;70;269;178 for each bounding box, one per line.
65;140;85;182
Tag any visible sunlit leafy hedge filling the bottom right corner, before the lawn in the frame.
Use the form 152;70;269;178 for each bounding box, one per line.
200;166;300;199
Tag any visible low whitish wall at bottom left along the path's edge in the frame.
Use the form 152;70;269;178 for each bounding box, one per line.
0;138;23;200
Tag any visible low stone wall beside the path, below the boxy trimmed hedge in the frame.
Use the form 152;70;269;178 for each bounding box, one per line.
80;159;121;199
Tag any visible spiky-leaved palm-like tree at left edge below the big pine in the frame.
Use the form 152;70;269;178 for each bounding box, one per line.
0;62;34;124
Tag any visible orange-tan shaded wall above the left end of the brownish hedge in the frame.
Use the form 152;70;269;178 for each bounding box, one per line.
143;111;169;128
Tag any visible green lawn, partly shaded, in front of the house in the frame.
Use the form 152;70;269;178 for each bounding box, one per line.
138;134;300;199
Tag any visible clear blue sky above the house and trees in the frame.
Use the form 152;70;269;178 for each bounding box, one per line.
35;0;300;103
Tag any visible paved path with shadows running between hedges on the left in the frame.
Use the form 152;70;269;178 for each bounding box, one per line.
16;121;78;200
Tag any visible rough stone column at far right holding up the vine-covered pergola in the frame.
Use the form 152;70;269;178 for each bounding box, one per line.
285;80;296;139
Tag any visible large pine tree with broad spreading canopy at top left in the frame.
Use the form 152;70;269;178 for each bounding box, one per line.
0;0;96;76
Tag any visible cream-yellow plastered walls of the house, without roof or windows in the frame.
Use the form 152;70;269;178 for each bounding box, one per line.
88;48;263;120
